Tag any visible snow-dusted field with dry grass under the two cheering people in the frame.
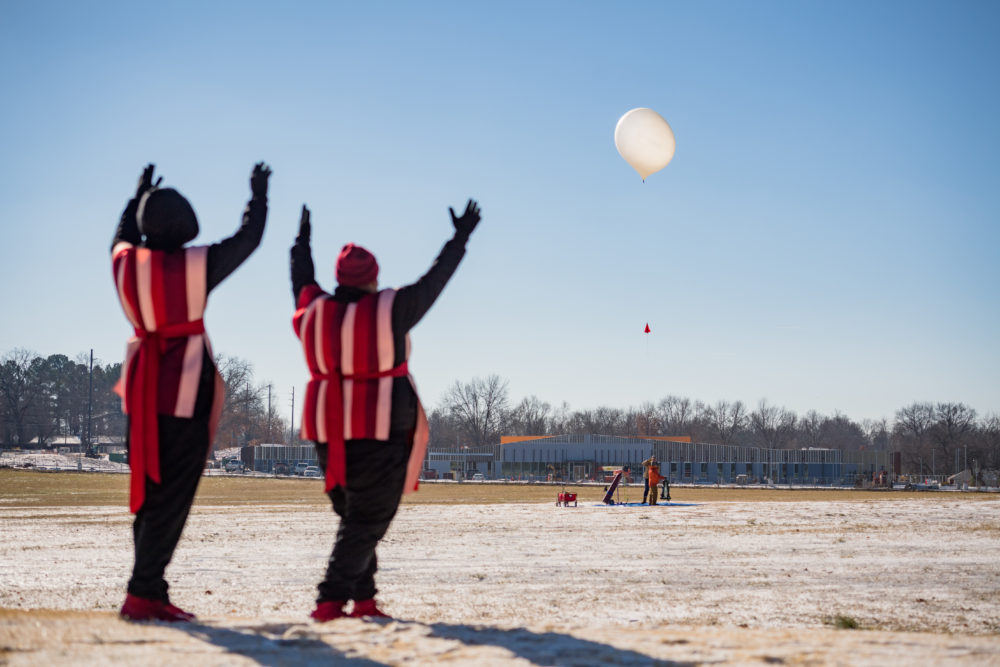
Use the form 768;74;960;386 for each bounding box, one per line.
0;492;1000;665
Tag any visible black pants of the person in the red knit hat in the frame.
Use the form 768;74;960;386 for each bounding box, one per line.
316;436;411;602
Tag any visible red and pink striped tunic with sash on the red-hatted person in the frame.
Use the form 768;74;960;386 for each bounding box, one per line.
292;285;427;492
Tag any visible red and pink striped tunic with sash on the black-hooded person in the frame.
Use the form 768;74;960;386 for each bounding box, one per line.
111;241;223;512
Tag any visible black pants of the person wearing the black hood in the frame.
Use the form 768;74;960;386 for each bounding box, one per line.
128;415;209;601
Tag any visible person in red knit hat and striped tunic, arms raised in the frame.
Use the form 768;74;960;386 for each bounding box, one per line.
291;199;480;622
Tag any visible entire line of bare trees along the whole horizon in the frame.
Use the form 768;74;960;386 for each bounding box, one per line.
0;349;1000;474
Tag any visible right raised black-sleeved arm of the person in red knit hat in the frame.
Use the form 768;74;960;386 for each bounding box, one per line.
392;199;481;331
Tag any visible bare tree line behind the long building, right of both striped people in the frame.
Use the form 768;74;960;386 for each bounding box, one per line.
429;375;1000;474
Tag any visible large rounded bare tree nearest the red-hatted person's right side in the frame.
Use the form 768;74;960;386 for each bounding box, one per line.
443;375;508;446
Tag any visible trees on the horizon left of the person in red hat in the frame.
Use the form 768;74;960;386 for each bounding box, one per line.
0;349;296;449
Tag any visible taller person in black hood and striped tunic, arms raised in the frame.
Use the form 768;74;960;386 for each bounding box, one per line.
111;162;271;622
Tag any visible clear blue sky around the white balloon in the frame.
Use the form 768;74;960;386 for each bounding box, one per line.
0;1;1000;421
